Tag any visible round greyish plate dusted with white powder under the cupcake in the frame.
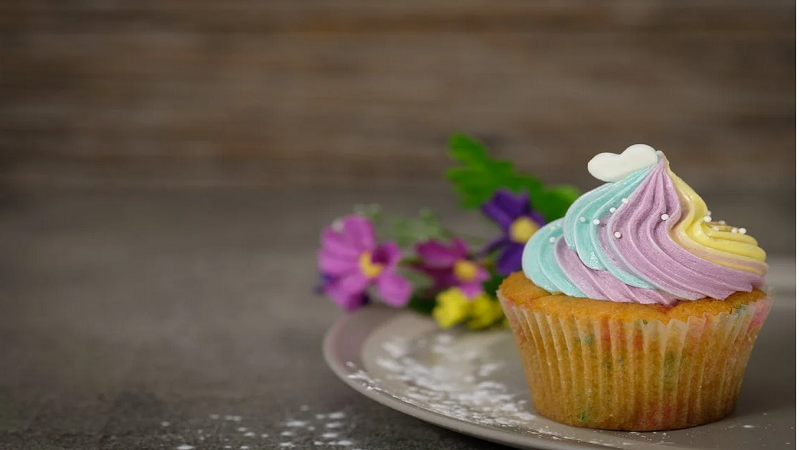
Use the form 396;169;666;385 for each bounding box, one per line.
324;282;795;450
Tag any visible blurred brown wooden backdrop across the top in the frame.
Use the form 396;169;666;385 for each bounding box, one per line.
0;0;795;199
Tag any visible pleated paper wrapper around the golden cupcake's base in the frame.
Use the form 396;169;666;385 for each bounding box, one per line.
498;293;772;431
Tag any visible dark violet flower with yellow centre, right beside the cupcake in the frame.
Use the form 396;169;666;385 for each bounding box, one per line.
481;189;547;275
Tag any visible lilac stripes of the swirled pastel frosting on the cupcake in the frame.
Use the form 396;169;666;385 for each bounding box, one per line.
540;157;763;305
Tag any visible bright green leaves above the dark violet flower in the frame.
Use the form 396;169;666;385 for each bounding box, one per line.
445;134;580;222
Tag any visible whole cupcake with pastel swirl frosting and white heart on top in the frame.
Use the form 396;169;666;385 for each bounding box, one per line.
498;145;772;431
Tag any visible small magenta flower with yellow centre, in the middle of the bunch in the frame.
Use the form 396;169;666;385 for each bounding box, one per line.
414;239;489;298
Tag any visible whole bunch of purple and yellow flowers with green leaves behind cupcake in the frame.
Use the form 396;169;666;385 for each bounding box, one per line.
318;134;579;329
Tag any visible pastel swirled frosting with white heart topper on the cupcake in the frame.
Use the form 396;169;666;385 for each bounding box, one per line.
522;145;767;305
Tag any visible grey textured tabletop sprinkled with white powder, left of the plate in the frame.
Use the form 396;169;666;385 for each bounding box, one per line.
0;189;792;450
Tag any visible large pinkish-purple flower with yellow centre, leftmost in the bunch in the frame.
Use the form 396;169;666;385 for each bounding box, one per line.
318;215;412;311
